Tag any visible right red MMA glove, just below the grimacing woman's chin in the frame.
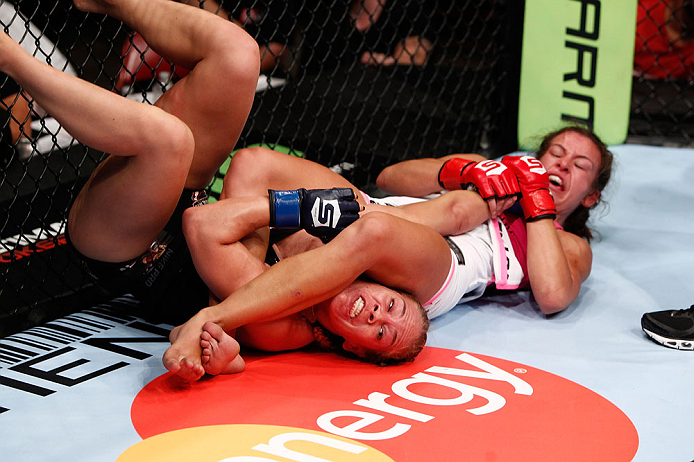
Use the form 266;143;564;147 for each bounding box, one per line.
501;156;557;221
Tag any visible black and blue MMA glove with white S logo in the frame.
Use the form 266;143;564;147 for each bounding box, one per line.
268;188;361;242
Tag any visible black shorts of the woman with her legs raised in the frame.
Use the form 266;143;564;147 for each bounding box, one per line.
65;190;209;324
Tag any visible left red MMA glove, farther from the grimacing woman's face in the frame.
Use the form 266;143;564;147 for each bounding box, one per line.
439;159;520;200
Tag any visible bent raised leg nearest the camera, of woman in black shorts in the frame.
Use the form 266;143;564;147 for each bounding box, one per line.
0;26;193;261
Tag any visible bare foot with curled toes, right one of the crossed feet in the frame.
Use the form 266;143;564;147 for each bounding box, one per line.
200;322;246;375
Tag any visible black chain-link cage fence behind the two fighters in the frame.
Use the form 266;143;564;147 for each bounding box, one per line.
0;0;694;335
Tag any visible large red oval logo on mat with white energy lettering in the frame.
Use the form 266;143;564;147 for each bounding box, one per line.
132;347;638;462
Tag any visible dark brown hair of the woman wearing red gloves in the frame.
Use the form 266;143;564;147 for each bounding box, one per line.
535;125;614;242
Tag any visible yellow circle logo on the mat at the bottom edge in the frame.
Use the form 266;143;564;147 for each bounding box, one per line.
117;425;393;462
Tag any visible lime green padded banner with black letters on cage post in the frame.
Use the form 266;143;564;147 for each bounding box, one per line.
518;0;637;150
